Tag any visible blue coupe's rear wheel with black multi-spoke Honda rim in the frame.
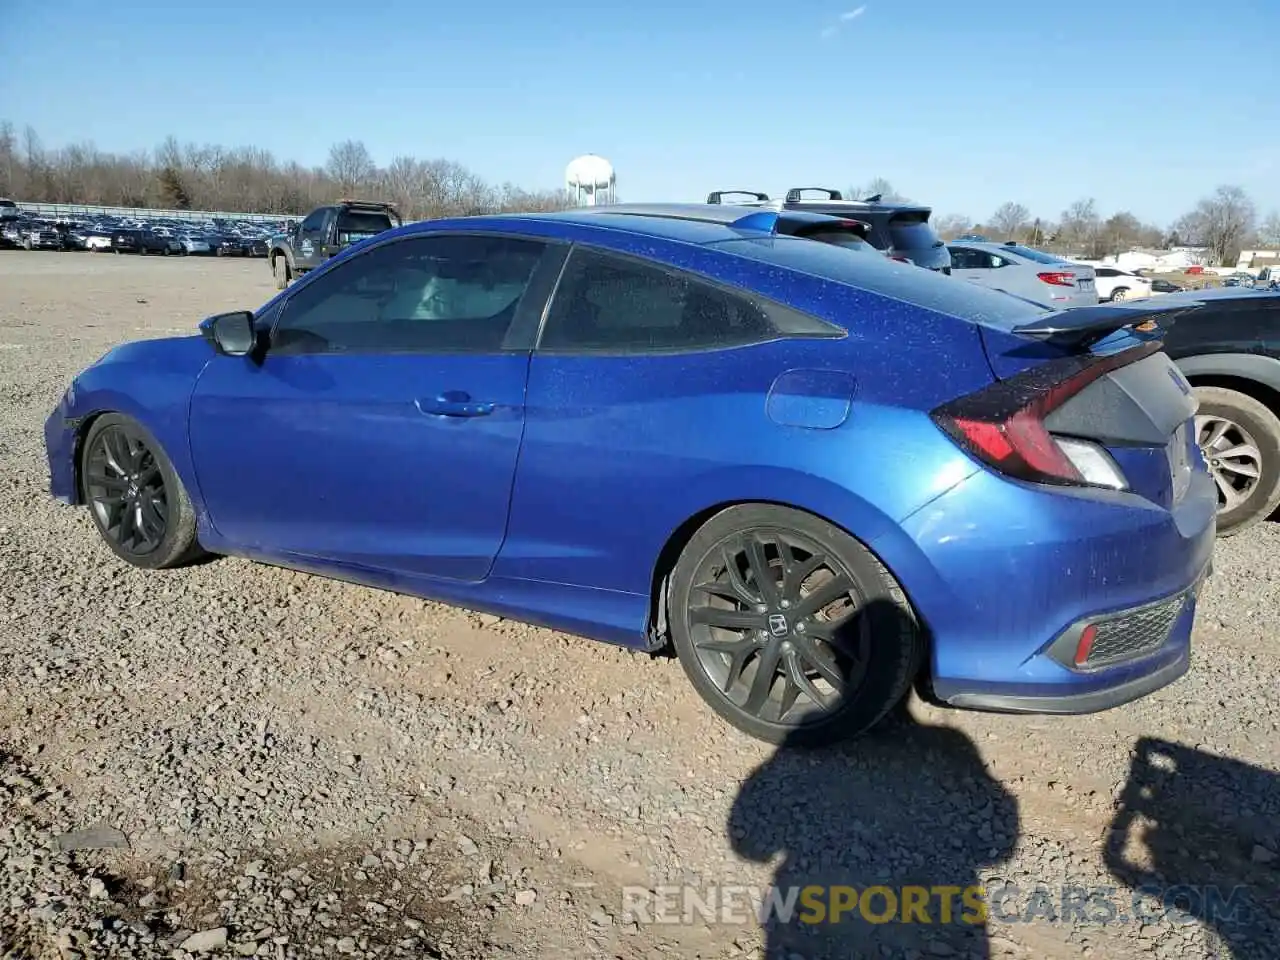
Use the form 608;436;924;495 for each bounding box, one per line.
667;504;923;746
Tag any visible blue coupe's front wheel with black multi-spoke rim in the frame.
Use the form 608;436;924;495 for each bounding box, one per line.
79;413;204;570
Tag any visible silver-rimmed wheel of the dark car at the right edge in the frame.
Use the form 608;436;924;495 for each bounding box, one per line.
1196;387;1280;536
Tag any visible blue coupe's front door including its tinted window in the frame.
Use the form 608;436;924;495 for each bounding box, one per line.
191;234;558;581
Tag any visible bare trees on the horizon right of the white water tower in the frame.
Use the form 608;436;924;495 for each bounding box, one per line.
849;178;1280;266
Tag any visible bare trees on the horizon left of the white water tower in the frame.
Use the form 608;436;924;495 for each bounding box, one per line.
0;122;568;220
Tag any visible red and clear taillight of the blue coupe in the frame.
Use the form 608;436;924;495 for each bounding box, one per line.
932;343;1160;490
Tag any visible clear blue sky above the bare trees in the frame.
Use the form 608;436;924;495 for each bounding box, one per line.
0;0;1280;223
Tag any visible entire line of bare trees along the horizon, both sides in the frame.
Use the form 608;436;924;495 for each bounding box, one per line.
0;122;1280;266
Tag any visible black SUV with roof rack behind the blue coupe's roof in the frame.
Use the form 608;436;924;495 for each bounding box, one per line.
707;187;951;274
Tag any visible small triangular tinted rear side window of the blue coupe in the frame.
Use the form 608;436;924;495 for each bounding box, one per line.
539;244;847;353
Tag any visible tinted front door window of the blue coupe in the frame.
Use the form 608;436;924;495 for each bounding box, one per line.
271;237;544;353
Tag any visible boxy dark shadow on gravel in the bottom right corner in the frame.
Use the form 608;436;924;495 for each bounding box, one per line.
1106;737;1280;960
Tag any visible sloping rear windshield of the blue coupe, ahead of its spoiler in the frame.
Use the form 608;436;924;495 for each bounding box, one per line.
716;237;1053;333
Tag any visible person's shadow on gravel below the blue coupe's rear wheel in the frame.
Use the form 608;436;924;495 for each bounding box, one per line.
728;708;1019;960
